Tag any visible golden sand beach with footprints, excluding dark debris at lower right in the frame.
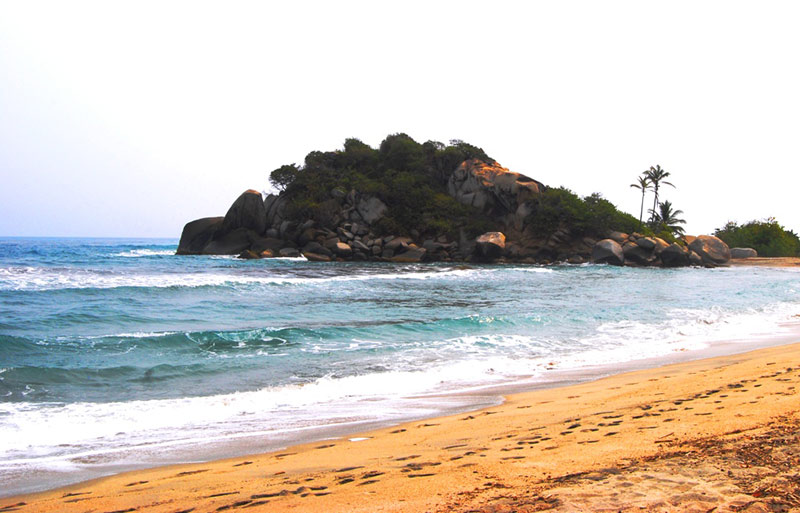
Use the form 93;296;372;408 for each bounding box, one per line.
9;336;800;512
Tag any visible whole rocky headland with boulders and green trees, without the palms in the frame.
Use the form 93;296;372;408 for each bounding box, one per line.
177;134;731;267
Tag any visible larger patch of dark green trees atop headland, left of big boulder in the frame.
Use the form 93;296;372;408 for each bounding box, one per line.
270;134;494;234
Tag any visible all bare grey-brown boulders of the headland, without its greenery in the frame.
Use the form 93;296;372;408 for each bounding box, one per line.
178;159;755;267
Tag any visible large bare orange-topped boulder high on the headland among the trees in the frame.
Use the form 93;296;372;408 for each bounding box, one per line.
447;159;544;215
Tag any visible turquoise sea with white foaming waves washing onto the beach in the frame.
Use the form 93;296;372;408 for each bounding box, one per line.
0;239;800;495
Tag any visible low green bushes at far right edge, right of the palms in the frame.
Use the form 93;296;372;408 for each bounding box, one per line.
714;217;800;257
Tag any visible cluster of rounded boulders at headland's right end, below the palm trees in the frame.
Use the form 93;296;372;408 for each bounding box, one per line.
592;232;731;267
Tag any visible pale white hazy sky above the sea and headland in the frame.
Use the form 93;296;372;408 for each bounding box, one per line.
0;0;800;237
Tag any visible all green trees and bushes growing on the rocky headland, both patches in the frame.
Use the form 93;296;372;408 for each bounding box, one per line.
270;134;638;241
